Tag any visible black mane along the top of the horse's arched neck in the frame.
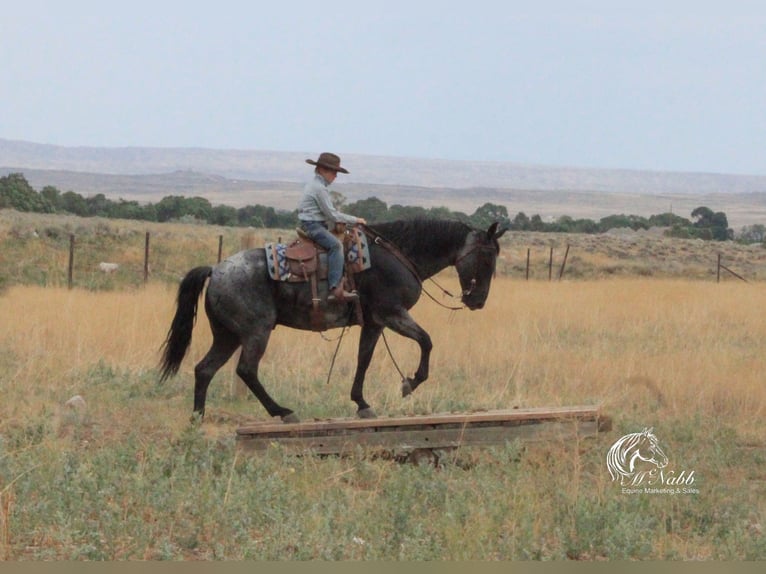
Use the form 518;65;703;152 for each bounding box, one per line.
369;218;471;255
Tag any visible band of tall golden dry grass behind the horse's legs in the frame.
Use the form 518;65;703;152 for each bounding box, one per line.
0;275;766;440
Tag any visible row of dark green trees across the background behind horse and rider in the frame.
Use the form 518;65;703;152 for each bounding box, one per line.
0;173;744;243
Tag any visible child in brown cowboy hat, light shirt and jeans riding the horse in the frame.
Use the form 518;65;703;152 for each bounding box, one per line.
298;152;367;302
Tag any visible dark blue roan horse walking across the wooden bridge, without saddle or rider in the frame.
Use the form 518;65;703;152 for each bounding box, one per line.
160;219;505;422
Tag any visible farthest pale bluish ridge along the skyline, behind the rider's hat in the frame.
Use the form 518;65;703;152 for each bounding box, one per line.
0;139;766;193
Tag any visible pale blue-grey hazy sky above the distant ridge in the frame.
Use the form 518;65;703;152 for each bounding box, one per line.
0;0;766;175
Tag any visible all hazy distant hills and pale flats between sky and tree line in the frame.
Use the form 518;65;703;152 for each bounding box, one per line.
0;139;766;230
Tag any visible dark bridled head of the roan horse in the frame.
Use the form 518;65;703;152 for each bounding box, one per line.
455;222;506;310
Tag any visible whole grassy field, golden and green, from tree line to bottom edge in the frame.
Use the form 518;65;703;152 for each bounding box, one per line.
0;209;766;560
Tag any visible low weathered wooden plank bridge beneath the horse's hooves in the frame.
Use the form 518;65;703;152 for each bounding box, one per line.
237;406;599;454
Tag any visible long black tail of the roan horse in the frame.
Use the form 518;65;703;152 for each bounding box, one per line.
160;266;213;382
